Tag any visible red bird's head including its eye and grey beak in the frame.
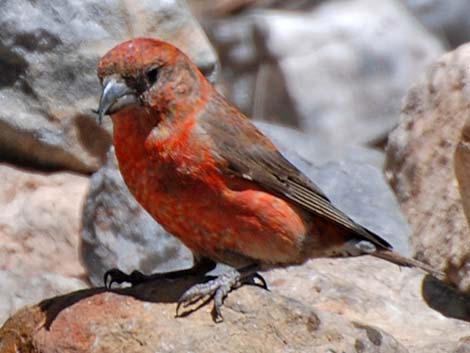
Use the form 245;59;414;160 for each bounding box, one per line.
98;38;208;122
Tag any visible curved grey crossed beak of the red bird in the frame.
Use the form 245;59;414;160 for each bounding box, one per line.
98;75;137;124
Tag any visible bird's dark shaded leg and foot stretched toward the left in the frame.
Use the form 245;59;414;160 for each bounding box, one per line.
103;258;216;288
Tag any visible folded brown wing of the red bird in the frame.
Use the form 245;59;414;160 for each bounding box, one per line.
199;96;391;248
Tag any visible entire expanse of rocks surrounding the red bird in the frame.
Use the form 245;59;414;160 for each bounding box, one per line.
0;0;470;353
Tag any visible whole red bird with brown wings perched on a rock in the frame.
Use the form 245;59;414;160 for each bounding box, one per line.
97;38;443;319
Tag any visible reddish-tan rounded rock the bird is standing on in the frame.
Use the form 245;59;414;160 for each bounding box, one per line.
0;278;407;353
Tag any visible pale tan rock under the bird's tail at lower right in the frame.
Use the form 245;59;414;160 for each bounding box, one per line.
265;256;470;353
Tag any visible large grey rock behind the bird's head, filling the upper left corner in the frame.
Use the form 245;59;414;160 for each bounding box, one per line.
0;0;217;172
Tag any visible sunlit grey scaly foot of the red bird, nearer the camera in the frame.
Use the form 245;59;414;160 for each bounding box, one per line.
176;264;268;322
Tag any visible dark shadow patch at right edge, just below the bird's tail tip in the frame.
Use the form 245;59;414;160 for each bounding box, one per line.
421;275;470;321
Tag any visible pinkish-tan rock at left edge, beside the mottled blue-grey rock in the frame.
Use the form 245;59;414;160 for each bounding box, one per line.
0;165;88;277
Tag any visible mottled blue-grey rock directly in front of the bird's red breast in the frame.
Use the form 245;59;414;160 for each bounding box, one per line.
80;149;192;286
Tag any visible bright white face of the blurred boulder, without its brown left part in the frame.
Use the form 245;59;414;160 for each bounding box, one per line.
255;0;442;143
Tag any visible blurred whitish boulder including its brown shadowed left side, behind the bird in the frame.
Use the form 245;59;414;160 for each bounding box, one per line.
207;0;443;144
